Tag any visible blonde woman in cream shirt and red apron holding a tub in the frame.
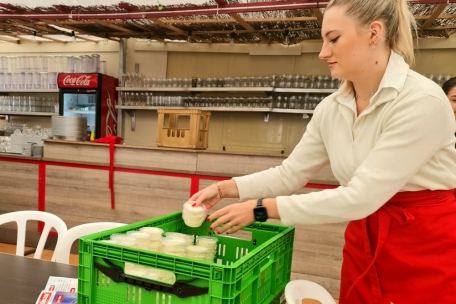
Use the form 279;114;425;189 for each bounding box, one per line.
191;0;456;304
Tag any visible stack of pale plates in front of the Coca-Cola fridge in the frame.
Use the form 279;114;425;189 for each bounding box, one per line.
52;116;87;141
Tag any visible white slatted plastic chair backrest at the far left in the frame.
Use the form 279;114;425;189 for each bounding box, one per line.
0;210;67;259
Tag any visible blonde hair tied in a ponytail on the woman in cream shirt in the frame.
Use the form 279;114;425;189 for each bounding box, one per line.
326;0;417;66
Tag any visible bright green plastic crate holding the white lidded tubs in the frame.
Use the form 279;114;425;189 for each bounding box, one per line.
78;212;294;304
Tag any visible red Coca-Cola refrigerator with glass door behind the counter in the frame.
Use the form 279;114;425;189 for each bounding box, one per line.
58;73;118;138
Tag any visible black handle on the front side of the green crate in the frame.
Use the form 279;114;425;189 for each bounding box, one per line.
94;259;209;298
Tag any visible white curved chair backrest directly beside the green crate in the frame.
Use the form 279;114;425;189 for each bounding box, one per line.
52;222;126;264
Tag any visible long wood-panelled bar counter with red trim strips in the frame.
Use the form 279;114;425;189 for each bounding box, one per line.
0;140;346;297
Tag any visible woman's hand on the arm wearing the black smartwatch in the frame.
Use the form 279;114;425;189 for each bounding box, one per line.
207;200;257;234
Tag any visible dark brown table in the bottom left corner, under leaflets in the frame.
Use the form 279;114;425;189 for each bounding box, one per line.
0;253;78;304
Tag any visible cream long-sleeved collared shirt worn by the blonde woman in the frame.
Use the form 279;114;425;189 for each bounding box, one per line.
234;52;456;225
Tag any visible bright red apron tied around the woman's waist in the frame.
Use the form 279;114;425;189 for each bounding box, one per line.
339;190;456;304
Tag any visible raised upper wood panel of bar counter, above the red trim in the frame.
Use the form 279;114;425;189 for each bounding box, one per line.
43;139;339;186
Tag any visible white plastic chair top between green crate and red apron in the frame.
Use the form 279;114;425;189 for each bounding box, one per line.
285;280;336;304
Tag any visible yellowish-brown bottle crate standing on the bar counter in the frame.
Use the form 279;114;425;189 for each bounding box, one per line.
156;109;211;149
